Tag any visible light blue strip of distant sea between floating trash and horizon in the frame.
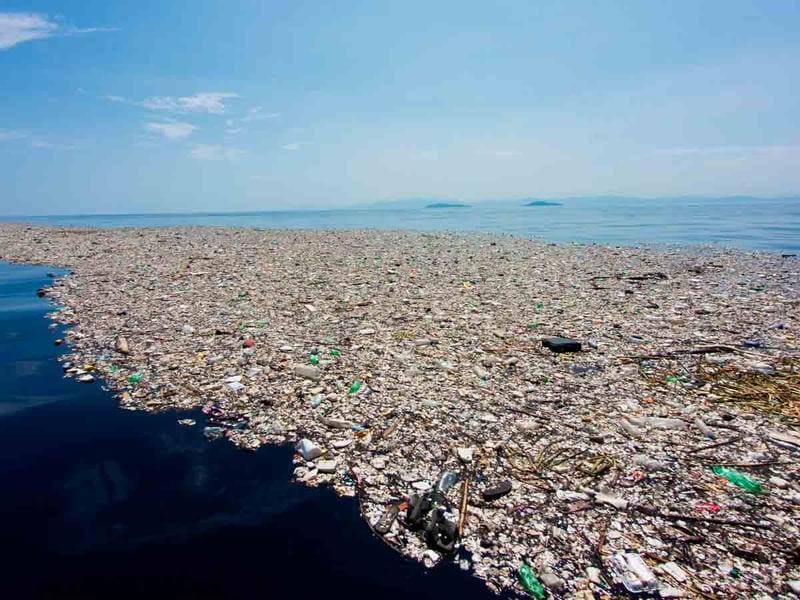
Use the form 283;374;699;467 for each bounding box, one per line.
6;198;800;252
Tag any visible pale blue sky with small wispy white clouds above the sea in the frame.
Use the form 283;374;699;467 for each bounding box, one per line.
0;0;800;215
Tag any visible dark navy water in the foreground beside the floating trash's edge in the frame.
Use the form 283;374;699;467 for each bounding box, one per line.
0;263;500;600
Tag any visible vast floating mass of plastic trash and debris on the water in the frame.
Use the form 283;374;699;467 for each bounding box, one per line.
0;224;800;599
